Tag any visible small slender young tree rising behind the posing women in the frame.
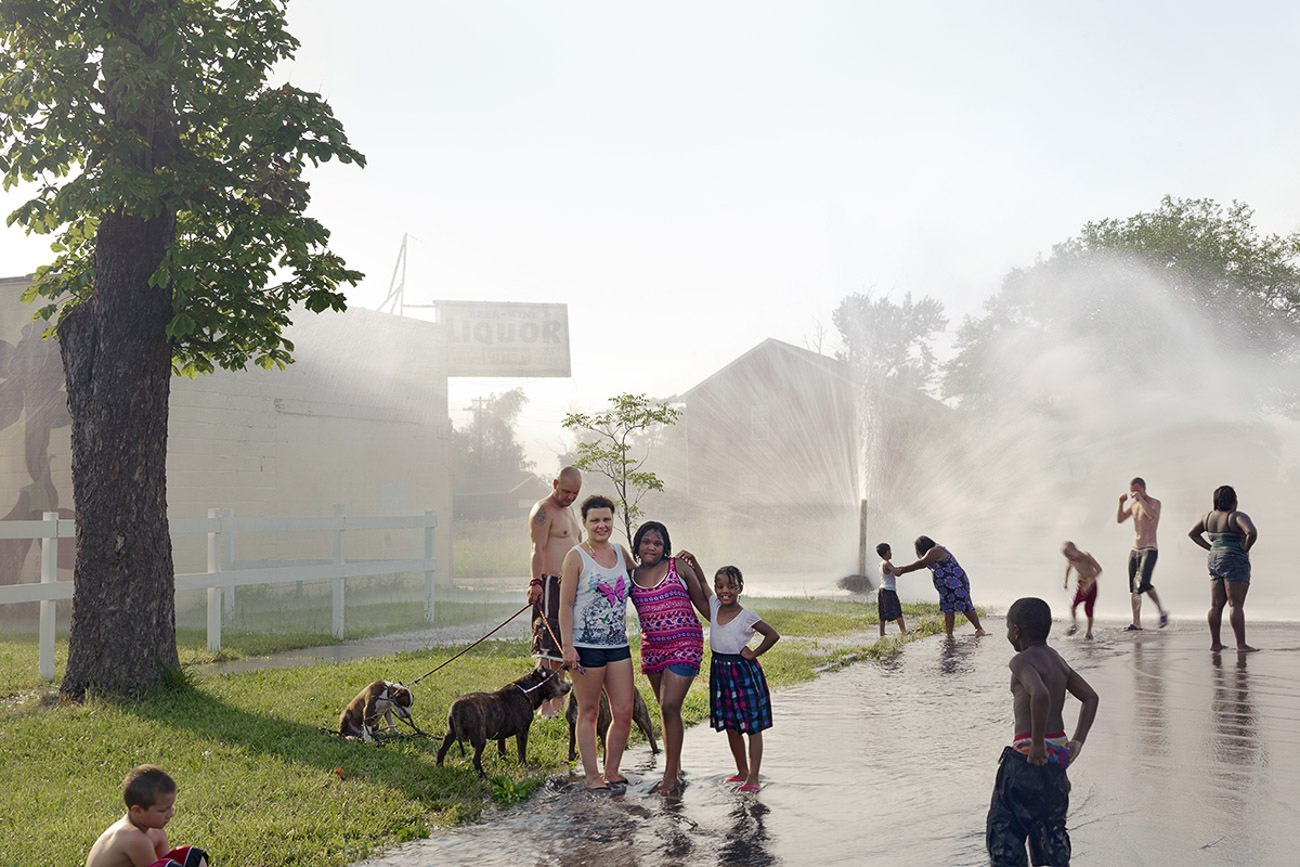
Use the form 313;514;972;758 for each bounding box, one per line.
560;394;681;543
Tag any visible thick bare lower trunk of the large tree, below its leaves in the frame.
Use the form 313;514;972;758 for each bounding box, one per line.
60;214;179;701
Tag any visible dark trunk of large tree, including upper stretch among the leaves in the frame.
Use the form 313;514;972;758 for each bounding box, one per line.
59;0;179;701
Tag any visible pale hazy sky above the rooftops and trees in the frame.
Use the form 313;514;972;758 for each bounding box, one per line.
0;0;1300;473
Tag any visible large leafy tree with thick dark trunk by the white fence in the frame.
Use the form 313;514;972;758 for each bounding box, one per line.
0;0;364;698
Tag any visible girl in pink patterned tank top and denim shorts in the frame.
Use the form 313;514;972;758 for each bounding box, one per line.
631;521;707;794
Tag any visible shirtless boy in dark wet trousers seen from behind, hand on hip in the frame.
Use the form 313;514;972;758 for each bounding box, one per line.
984;598;1099;867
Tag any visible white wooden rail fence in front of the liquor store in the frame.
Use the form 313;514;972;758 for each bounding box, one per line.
0;506;438;680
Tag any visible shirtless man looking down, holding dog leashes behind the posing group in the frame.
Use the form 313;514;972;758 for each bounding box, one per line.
528;467;582;716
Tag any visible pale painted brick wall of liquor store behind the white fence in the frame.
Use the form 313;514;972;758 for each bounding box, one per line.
0;279;451;582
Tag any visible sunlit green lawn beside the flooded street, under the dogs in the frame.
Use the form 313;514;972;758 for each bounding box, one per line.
0;599;941;867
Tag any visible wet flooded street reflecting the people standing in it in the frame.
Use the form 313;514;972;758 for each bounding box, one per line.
364;617;1300;867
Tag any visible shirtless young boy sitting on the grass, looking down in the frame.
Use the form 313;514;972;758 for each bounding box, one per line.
86;764;208;867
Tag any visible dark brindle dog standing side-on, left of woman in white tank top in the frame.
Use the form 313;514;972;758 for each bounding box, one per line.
438;668;572;777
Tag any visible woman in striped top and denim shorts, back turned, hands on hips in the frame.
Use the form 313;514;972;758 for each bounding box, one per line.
1187;485;1260;654
